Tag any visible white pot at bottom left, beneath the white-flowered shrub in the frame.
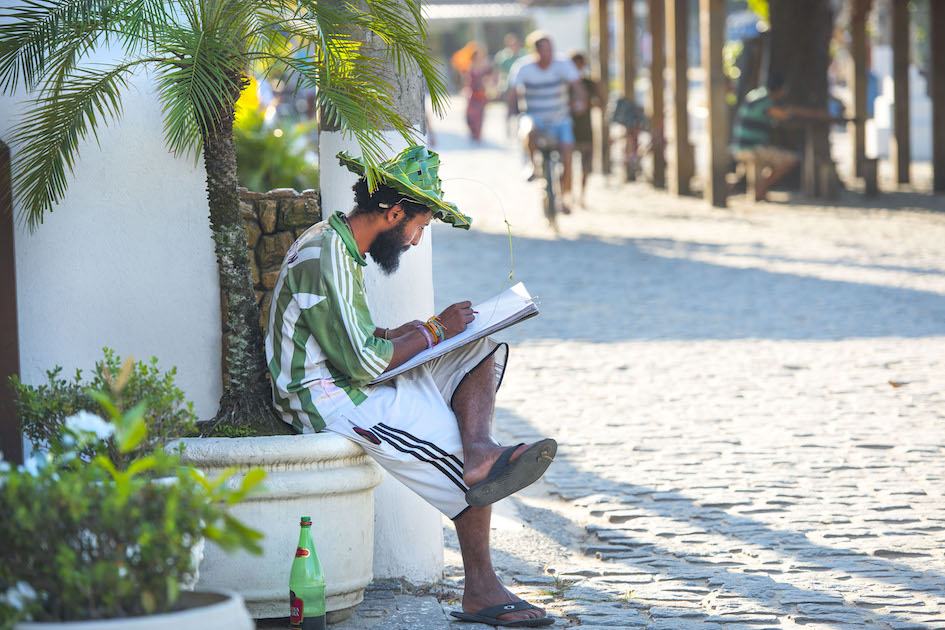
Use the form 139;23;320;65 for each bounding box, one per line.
13;591;256;630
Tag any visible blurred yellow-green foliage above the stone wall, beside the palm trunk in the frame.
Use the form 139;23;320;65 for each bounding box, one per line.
233;110;318;192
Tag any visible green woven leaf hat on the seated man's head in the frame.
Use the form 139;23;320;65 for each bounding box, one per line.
337;145;472;230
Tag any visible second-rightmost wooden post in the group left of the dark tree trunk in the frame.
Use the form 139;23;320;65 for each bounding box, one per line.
666;0;692;195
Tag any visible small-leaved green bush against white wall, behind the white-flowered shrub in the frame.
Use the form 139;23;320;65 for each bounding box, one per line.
10;348;197;467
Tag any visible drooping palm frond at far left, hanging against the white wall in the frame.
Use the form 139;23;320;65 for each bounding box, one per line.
12;63;136;231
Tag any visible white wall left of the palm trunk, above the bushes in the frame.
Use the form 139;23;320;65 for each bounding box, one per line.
0;71;221;419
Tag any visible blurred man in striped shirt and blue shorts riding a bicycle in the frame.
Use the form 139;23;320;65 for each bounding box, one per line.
509;31;587;214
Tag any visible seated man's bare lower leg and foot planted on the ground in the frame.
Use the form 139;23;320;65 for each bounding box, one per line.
454;506;545;621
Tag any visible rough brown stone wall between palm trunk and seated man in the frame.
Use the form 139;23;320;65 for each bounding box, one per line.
240;188;322;330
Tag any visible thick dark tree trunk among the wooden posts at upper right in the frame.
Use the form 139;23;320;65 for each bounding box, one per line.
768;0;835;188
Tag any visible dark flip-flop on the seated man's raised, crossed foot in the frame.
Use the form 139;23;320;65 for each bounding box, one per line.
466;438;558;507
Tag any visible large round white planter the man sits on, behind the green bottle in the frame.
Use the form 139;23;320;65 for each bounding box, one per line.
182;433;384;621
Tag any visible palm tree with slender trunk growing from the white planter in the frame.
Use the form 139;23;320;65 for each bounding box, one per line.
0;0;446;432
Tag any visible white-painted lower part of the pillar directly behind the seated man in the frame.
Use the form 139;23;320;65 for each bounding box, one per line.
318;131;443;584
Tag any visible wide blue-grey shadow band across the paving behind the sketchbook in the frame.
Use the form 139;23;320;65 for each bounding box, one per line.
433;230;945;342
